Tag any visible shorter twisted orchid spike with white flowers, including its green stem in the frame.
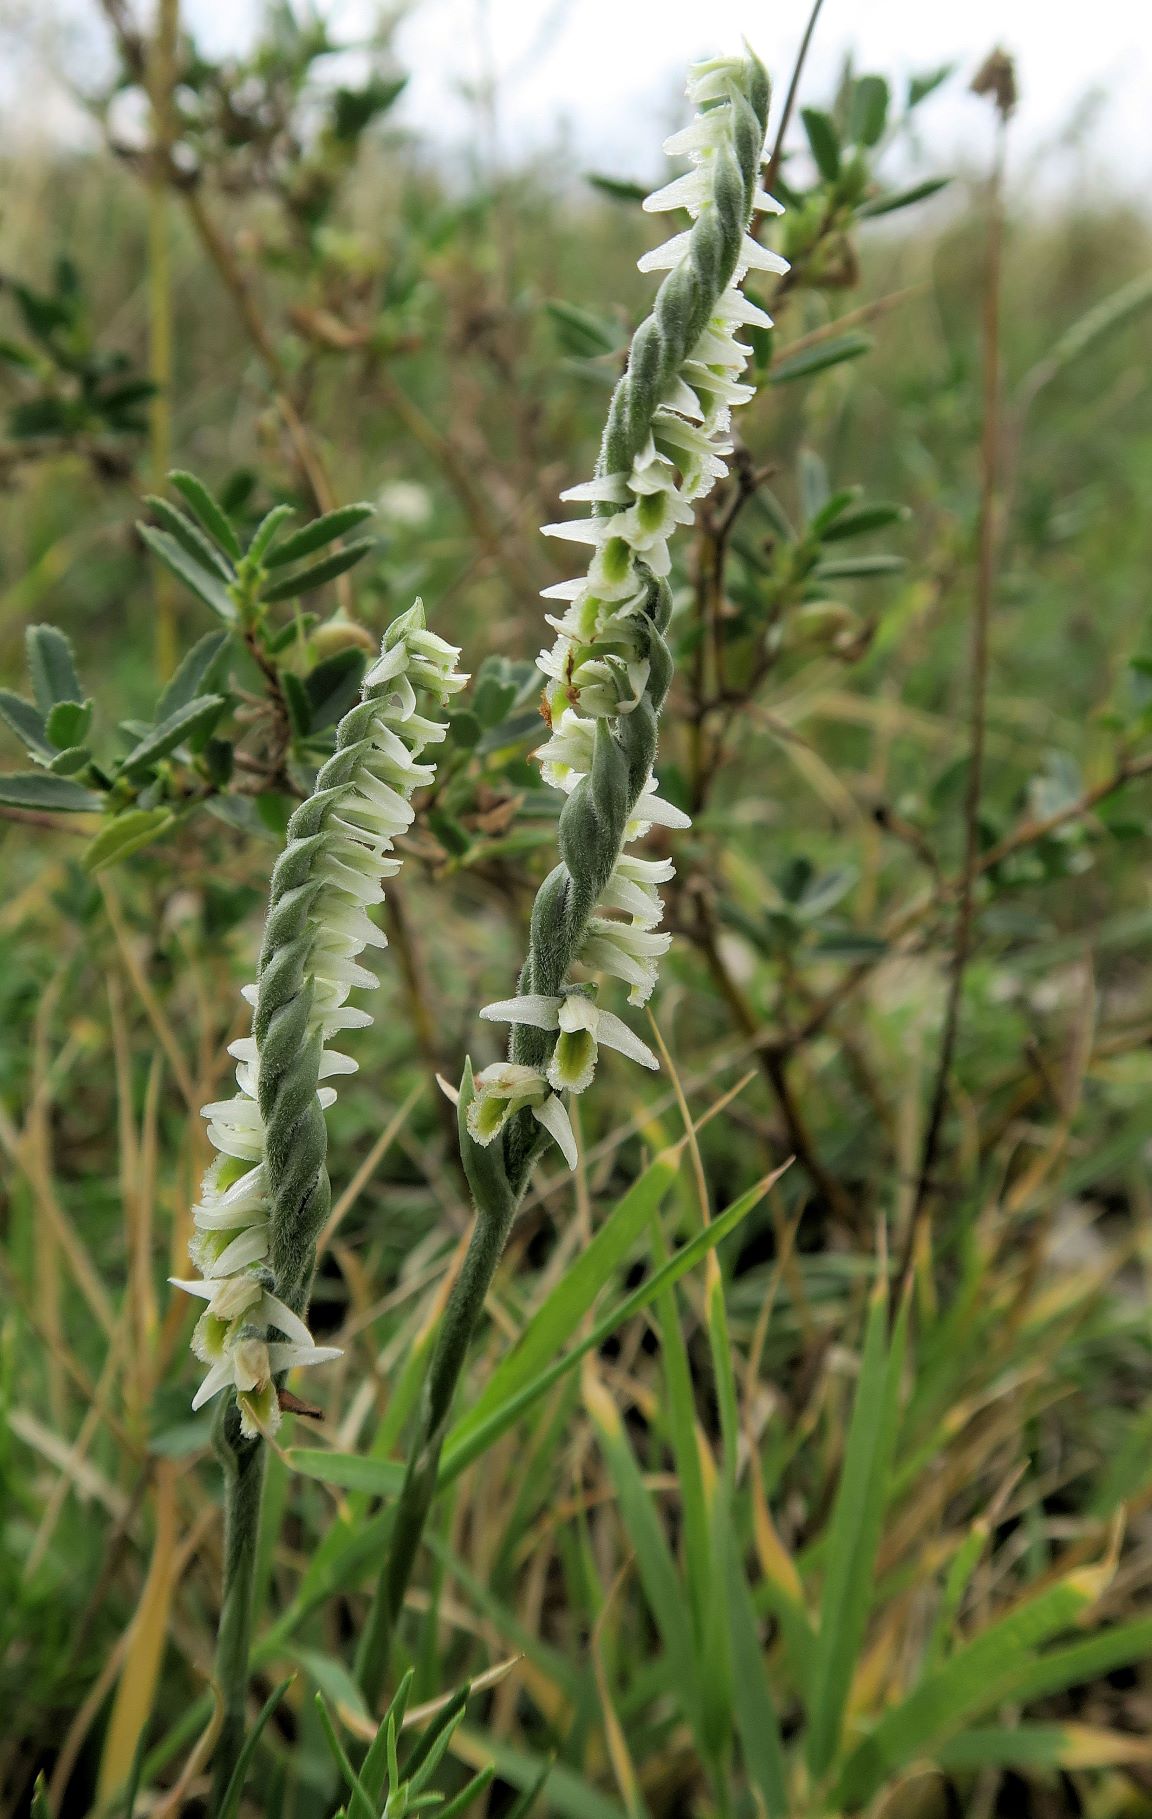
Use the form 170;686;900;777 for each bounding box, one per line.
177;602;468;1804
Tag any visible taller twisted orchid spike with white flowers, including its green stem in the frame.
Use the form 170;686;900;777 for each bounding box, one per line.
360;53;786;1703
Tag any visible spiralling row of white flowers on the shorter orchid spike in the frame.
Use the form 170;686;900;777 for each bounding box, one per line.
169;600;468;1439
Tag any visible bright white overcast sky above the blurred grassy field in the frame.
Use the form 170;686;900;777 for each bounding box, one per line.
0;0;1152;202
